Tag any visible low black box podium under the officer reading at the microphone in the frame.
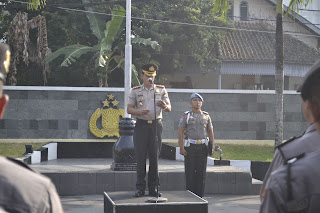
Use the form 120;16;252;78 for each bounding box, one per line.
104;191;208;213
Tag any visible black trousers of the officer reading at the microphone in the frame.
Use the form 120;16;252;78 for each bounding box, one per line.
133;119;162;191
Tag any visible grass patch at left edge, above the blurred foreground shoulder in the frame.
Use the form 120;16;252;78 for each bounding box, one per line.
0;143;47;158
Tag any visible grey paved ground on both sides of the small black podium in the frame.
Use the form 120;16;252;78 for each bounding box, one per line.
61;195;260;213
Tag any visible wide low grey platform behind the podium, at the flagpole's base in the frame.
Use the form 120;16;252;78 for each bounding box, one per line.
30;158;259;196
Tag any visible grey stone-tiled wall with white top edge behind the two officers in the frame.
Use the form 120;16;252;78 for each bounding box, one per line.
0;87;307;140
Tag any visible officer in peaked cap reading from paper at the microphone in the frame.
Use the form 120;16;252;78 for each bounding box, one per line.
127;64;171;197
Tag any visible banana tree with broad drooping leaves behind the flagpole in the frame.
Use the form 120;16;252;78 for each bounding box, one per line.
46;5;159;87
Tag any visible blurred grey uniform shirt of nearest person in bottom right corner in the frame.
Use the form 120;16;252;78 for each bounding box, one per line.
260;152;320;213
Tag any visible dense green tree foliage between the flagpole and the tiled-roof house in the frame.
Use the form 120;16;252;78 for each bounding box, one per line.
132;0;231;73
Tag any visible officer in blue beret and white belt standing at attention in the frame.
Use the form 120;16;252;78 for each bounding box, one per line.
178;93;214;197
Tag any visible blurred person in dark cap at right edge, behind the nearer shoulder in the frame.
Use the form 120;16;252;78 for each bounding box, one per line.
260;60;320;199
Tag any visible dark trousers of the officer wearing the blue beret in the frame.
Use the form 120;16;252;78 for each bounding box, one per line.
184;144;208;197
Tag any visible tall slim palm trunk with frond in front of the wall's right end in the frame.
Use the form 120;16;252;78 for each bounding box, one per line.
275;0;312;146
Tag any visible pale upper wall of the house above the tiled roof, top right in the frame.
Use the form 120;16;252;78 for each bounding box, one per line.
234;0;318;48
